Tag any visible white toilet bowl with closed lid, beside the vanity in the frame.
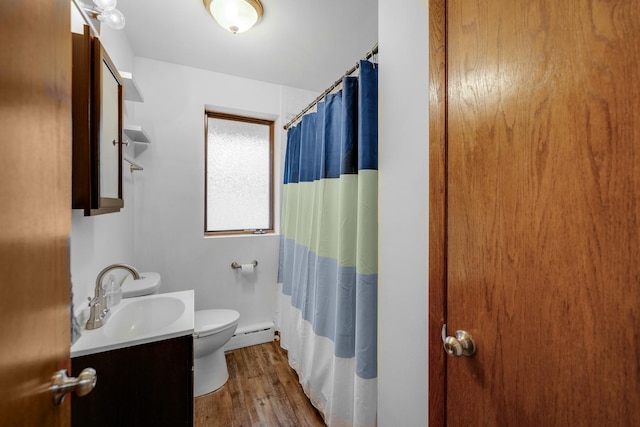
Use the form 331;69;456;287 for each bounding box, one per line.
193;309;240;396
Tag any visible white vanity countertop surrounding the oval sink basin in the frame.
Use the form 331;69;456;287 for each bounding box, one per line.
71;290;194;357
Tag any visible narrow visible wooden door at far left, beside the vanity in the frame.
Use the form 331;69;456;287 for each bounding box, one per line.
0;0;71;426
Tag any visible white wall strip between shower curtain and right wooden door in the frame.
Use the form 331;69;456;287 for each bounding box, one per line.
378;0;429;427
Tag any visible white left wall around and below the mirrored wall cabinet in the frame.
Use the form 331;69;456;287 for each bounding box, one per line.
70;9;136;312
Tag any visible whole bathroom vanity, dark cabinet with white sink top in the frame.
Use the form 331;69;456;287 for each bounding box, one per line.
71;291;194;427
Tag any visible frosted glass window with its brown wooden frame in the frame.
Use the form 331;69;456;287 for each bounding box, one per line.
205;112;273;234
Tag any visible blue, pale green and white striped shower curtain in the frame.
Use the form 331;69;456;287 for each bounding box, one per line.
276;61;378;426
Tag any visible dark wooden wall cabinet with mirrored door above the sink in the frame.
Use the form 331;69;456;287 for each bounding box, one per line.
72;26;124;216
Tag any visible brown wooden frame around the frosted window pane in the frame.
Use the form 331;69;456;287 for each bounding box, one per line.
203;110;276;237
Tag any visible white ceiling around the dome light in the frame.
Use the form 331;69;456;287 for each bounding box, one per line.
118;0;378;92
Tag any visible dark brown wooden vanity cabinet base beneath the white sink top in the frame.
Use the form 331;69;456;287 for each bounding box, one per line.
69;335;193;427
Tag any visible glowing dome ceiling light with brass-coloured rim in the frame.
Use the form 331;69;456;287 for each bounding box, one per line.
203;0;263;34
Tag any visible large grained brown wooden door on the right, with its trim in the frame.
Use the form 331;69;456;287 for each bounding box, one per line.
431;0;640;426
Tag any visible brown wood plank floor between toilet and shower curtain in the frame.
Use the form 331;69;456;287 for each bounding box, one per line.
194;341;325;427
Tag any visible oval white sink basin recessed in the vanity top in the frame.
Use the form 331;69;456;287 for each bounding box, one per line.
103;296;185;339
